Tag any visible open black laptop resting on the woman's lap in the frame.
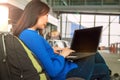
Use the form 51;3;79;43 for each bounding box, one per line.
67;26;103;60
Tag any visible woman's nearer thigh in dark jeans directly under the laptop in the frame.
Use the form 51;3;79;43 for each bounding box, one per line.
67;56;95;80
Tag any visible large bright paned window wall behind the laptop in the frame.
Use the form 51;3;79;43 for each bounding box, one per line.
61;14;120;46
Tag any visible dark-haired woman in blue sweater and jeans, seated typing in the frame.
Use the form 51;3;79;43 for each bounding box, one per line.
13;0;109;80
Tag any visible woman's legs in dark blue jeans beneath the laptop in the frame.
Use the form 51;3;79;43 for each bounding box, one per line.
67;53;109;80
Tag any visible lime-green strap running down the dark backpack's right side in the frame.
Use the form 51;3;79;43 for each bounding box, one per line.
17;38;47;80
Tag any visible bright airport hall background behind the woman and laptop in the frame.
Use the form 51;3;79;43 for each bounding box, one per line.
0;0;120;79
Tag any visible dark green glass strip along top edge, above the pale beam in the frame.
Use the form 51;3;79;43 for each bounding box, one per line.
48;0;120;6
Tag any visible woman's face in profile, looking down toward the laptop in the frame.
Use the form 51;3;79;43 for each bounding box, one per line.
36;14;48;29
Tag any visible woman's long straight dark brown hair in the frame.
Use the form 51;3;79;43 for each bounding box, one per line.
13;0;50;36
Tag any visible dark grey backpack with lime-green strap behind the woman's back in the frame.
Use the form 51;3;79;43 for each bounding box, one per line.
0;33;50;80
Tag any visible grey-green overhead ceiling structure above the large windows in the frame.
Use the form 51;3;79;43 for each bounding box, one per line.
47;0;120;15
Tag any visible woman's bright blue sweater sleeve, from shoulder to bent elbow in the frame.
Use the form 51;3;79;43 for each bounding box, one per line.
20;33;65;77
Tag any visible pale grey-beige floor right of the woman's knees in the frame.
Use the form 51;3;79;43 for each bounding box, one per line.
100;50;120;74
